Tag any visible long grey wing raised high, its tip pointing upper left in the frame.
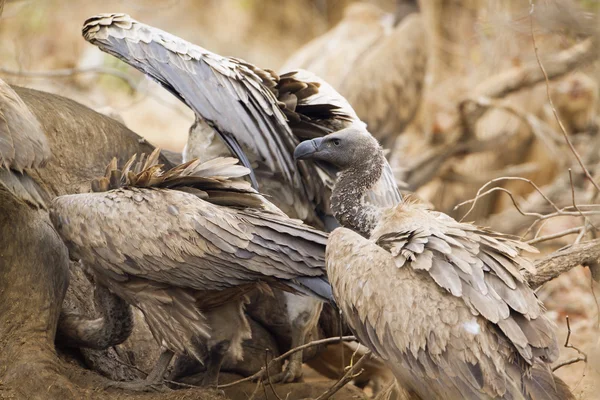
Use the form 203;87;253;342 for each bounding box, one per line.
83;14;301;187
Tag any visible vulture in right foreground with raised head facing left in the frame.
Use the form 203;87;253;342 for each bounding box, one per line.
294;128;574;400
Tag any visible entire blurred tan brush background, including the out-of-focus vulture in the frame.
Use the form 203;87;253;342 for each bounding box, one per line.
0;0;600;398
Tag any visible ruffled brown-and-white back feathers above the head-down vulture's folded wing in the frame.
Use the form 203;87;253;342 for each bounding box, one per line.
91;148;283;214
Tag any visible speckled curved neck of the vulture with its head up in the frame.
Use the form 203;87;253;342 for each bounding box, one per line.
331;150;385;237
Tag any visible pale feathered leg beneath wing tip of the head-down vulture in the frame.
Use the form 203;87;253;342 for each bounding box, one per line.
272;293;323;382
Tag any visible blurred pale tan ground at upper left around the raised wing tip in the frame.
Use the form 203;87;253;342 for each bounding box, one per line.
0;0;394;150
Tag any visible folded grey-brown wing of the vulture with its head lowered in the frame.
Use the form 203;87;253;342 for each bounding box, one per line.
51;188;327;295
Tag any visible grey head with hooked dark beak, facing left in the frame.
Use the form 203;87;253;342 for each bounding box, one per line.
294;128;383;170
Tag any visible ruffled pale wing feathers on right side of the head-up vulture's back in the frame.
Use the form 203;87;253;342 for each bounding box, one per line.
372;204;558;374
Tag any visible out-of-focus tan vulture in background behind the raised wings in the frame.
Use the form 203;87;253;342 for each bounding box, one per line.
282;1;427;150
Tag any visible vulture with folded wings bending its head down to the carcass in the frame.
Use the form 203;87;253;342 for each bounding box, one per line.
50;149;331;389
